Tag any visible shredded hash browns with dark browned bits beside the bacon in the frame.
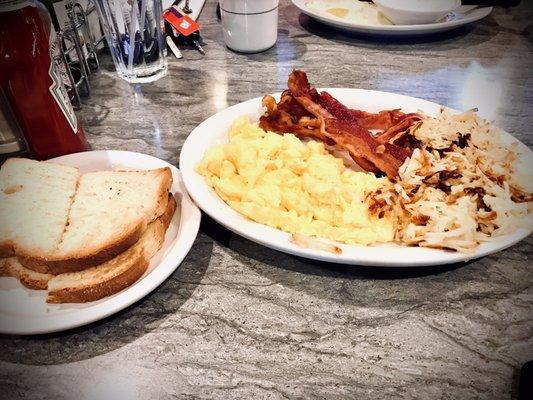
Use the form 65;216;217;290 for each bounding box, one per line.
368;109;533;252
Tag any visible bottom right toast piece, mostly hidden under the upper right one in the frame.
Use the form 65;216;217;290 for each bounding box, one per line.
46;195;176;303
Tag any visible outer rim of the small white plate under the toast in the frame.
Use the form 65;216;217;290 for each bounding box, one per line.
0;150;201;335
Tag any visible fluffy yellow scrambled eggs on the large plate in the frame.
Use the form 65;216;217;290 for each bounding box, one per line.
197;118;394;244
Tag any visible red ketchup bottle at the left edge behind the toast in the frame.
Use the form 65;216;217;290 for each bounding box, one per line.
0;0;87;160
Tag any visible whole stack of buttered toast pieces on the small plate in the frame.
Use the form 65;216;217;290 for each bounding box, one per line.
0;159;176;303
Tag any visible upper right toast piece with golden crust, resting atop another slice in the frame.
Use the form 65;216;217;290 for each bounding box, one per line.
17;168;172;275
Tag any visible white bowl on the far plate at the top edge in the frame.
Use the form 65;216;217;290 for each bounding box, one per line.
372;0;461;25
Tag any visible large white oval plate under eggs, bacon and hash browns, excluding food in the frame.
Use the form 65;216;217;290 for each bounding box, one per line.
180;89;533;267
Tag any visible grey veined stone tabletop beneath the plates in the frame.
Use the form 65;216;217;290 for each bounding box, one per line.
0;0;533;399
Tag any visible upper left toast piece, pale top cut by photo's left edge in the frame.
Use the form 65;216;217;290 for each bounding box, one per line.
0;158;79;257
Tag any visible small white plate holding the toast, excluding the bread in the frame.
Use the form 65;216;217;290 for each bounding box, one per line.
0;151;201;335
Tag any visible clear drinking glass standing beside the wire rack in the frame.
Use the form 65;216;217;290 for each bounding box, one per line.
96;0;167;83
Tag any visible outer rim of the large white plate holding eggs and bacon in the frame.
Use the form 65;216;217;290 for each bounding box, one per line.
179;88;531;268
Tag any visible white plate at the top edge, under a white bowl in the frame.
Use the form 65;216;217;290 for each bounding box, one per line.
292;0;492;36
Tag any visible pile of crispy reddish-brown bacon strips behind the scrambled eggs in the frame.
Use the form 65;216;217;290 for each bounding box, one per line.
259;70;421;178
